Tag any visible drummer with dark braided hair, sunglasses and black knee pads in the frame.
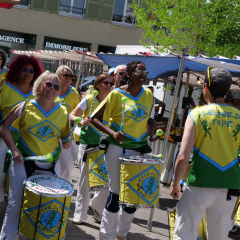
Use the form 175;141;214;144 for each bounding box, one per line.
92;61;157;240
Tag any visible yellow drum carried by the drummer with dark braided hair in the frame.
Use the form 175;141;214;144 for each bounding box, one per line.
119;156;162;208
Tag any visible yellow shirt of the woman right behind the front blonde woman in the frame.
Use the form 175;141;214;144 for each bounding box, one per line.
55;86;80;113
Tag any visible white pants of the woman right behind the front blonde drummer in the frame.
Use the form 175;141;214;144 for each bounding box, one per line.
59;141;74;183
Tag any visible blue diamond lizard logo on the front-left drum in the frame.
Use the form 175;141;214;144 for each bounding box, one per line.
23;199;69;239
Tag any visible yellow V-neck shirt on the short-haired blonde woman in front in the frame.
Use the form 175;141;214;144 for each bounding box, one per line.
12;99;70;162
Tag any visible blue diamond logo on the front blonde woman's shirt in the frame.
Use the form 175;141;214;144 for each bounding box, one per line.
28;120;60;142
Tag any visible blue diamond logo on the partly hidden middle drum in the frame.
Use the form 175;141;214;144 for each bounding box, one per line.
89;152;109;187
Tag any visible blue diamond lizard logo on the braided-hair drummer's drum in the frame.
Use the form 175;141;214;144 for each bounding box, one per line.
126;166;159;204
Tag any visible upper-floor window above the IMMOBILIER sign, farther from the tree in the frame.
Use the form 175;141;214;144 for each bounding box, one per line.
59;0;86;15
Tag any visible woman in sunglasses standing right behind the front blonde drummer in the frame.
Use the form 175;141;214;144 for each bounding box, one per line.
55;65;80;182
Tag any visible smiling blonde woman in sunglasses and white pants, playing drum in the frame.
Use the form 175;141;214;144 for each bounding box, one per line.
0;73;71;240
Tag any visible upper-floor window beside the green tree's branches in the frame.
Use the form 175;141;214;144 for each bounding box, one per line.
112;0;139;24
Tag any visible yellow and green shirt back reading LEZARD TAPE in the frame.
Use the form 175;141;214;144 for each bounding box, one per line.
187;104;240;189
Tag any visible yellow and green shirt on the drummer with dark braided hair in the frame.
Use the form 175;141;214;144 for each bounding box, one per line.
92;87;154;149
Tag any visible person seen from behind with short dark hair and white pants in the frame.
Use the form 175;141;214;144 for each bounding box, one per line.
170;67;240;240
